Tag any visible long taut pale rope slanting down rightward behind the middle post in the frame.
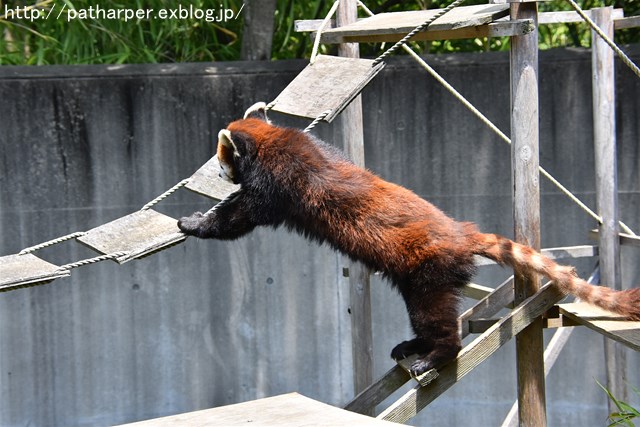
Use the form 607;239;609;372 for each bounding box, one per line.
358;0;635;236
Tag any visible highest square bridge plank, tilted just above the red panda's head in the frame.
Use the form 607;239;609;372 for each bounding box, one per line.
272;55;384;122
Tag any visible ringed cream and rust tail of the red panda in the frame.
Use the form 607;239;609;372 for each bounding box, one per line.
473;233;640;320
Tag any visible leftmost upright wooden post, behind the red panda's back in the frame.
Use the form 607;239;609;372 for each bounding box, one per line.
336;0;373;402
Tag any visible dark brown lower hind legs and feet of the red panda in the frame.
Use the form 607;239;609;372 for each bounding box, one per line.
391;285;462;376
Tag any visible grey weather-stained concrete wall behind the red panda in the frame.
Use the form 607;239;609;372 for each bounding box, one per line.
0;45;640;426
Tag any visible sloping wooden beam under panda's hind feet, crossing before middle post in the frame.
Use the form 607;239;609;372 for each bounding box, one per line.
377;285;564;423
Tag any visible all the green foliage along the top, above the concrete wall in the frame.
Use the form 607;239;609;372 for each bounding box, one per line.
0;0;640;65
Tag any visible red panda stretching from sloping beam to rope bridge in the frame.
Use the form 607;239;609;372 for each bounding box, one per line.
178;103;640;375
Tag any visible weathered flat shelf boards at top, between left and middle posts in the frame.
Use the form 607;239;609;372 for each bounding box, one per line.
321;5;509;43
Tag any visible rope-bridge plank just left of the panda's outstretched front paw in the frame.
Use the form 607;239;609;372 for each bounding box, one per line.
78;209;187;264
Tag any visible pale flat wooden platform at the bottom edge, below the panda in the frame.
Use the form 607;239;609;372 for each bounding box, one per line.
116;393;399;427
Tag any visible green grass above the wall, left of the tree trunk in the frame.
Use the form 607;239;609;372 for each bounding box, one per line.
0;0;242;65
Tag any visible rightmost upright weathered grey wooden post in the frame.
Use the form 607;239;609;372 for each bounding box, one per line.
591;7;628;413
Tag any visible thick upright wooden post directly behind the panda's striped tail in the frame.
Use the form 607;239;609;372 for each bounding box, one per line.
511;2;547;427
